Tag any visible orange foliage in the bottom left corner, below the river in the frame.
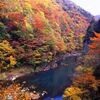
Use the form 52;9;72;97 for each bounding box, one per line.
0;84;40;100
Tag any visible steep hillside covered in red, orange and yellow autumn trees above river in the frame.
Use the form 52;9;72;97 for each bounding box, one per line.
0;0;92;69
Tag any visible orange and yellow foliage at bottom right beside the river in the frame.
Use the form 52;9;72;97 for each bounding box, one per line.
63;66;100;100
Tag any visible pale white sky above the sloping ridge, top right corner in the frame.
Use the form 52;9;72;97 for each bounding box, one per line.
71;0;100;15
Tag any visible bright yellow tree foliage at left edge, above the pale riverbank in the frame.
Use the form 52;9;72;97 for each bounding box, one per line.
0;40;17;70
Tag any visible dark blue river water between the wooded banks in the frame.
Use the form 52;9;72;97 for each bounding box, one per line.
17;57;77;97
